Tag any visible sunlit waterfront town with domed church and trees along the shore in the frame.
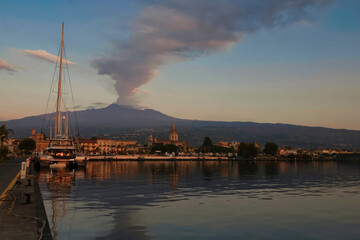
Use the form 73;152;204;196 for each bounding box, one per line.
0;123;360;160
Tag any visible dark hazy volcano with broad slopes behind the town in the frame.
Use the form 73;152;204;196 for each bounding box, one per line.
2;104;360;148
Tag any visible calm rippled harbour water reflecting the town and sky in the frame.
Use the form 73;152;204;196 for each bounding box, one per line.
39;161;360;240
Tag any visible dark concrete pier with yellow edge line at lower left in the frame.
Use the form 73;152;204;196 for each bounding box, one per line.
0;158;52;240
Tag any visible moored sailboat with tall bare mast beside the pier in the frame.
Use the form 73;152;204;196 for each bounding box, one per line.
40;23;82;167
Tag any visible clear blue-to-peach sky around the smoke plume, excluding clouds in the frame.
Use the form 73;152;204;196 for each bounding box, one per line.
0;0;360;129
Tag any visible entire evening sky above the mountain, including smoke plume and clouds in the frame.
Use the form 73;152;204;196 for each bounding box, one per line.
0;0;360;130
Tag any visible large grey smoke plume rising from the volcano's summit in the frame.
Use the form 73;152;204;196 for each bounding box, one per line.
92;0;333;105
